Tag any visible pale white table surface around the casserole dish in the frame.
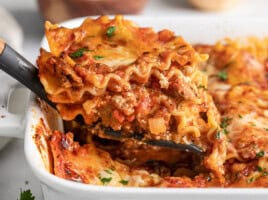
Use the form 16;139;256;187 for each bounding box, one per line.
0;0;268;200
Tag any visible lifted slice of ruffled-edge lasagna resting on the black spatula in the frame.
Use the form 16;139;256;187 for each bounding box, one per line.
37;16;219;150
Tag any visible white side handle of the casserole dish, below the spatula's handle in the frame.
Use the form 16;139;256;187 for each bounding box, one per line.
0;84;30;138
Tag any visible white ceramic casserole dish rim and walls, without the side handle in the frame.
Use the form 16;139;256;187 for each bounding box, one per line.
3;17;268;200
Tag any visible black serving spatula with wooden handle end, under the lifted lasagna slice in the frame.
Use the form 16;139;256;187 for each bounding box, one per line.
0;40;203;153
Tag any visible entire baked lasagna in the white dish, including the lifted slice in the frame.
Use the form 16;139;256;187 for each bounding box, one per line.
36;16;268;187
